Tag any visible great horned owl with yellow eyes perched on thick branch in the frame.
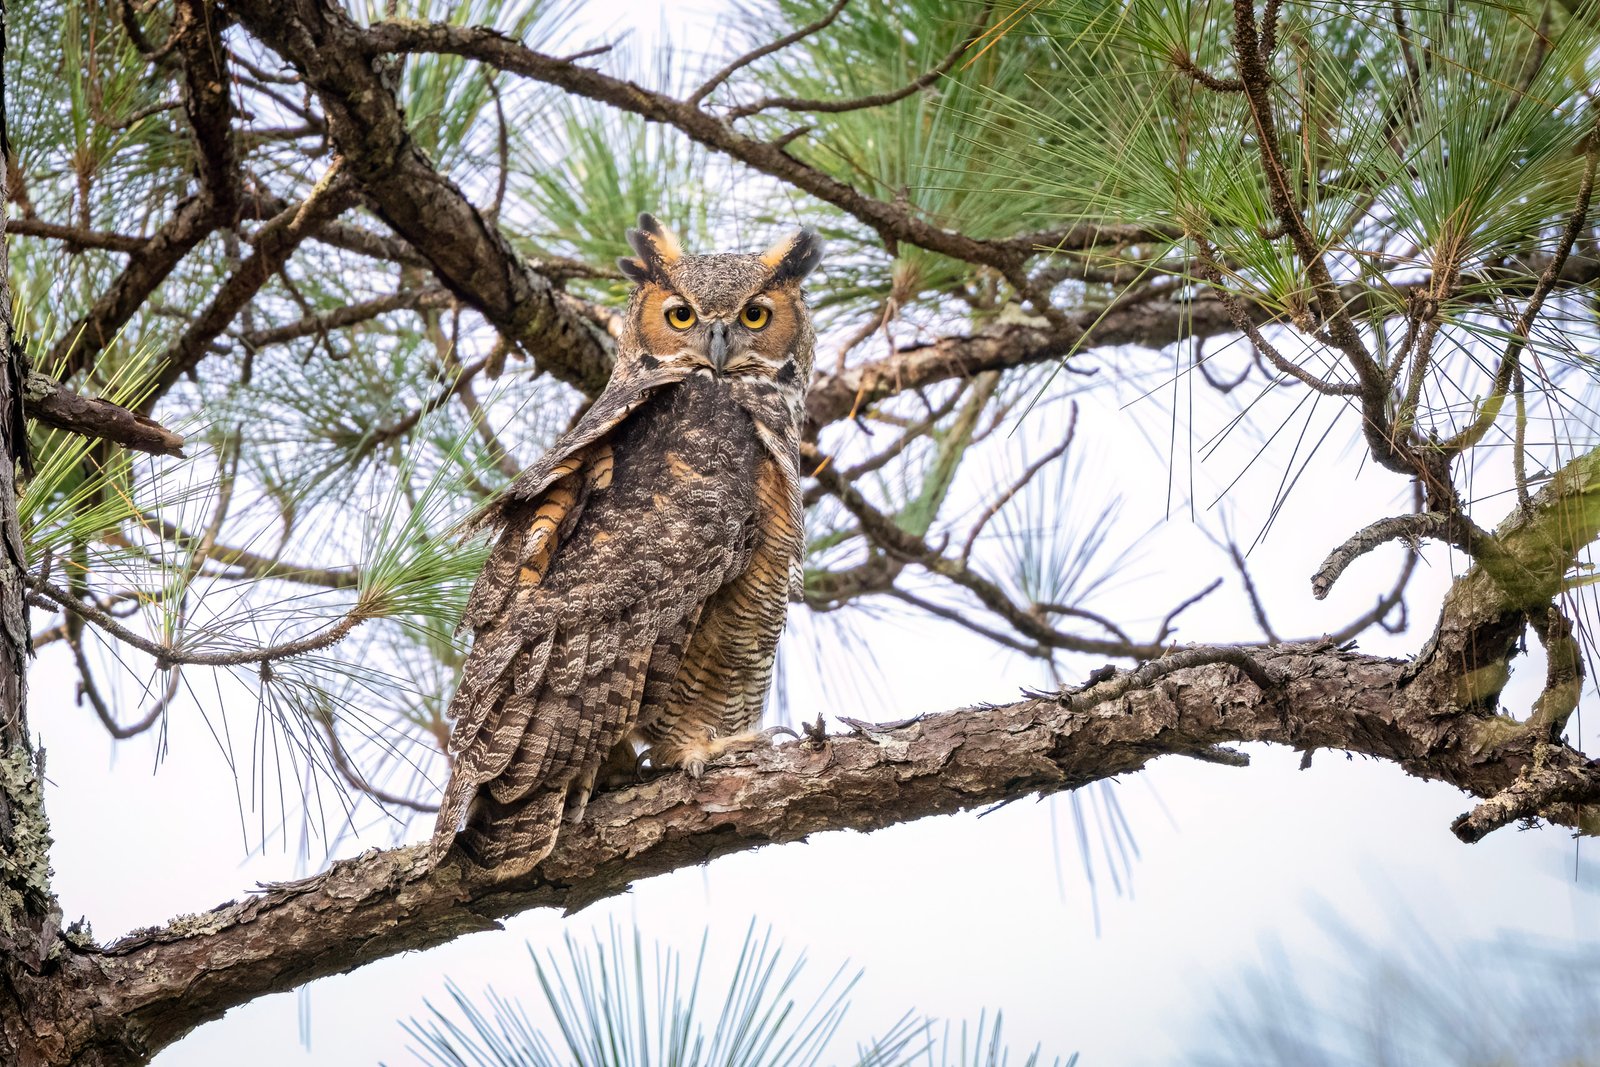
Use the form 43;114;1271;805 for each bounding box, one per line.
430;214;822;875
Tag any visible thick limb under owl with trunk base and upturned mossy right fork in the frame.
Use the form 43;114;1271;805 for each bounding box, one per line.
0;450;1600;1065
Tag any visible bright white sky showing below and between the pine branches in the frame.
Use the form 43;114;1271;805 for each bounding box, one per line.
32;0;1600;1067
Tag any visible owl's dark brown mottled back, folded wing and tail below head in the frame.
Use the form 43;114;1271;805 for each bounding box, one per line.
430;374;770;873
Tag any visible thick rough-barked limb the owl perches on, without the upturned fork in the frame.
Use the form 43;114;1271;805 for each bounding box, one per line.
31;646;1600;1054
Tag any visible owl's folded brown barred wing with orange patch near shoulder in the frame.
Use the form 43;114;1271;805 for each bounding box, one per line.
430;375;754;865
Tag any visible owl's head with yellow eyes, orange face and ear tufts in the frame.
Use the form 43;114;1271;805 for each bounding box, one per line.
618;214;822;390
